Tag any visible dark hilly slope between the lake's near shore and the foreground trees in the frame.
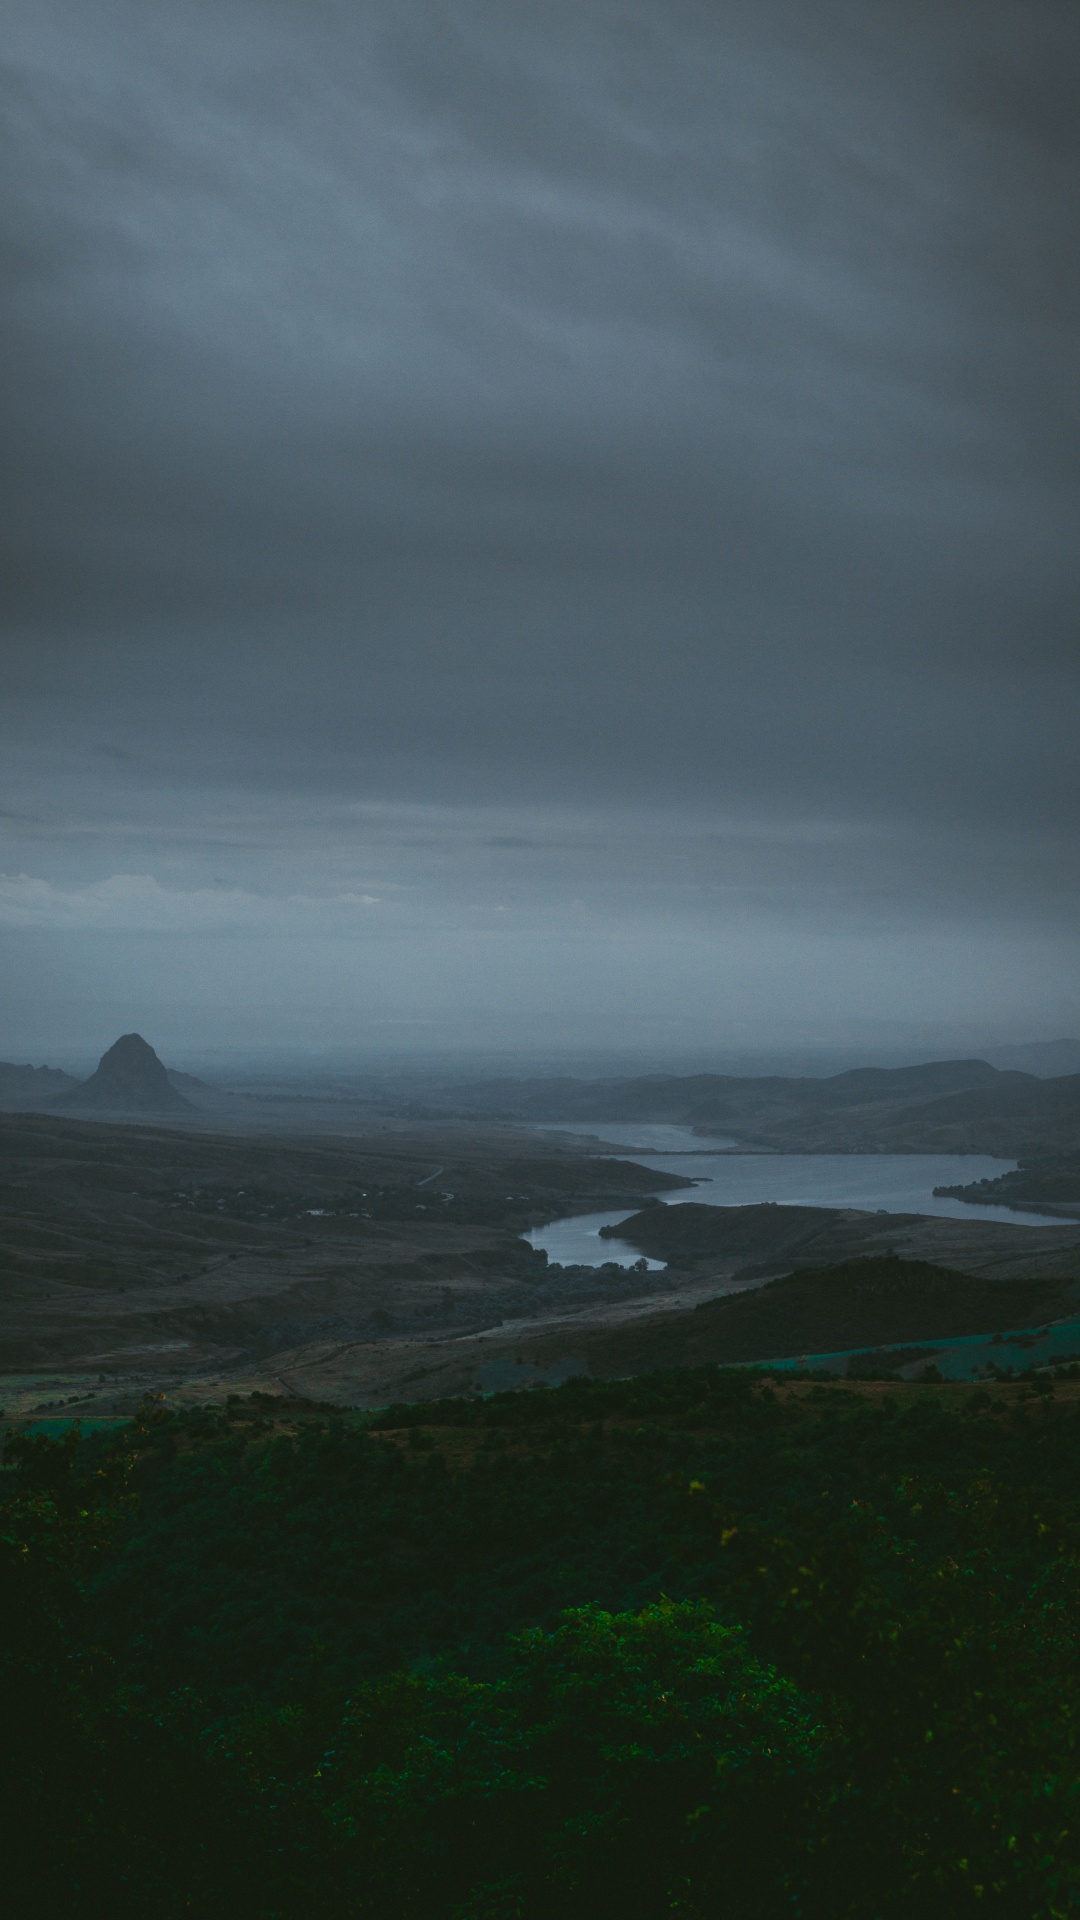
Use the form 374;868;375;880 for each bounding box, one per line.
130;1204;1080;1405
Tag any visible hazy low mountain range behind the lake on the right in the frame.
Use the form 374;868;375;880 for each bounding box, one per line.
455;1060;1080;1158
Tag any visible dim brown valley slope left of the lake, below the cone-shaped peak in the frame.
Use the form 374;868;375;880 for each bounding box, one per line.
0;1116;686;1379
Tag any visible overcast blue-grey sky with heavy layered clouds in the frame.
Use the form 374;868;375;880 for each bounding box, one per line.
0;0;1080;1058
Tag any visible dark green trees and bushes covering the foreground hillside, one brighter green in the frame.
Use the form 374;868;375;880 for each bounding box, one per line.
0;1367;1080;1920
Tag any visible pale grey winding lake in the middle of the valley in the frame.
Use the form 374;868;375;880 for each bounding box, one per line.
525;1121;1063;1267
